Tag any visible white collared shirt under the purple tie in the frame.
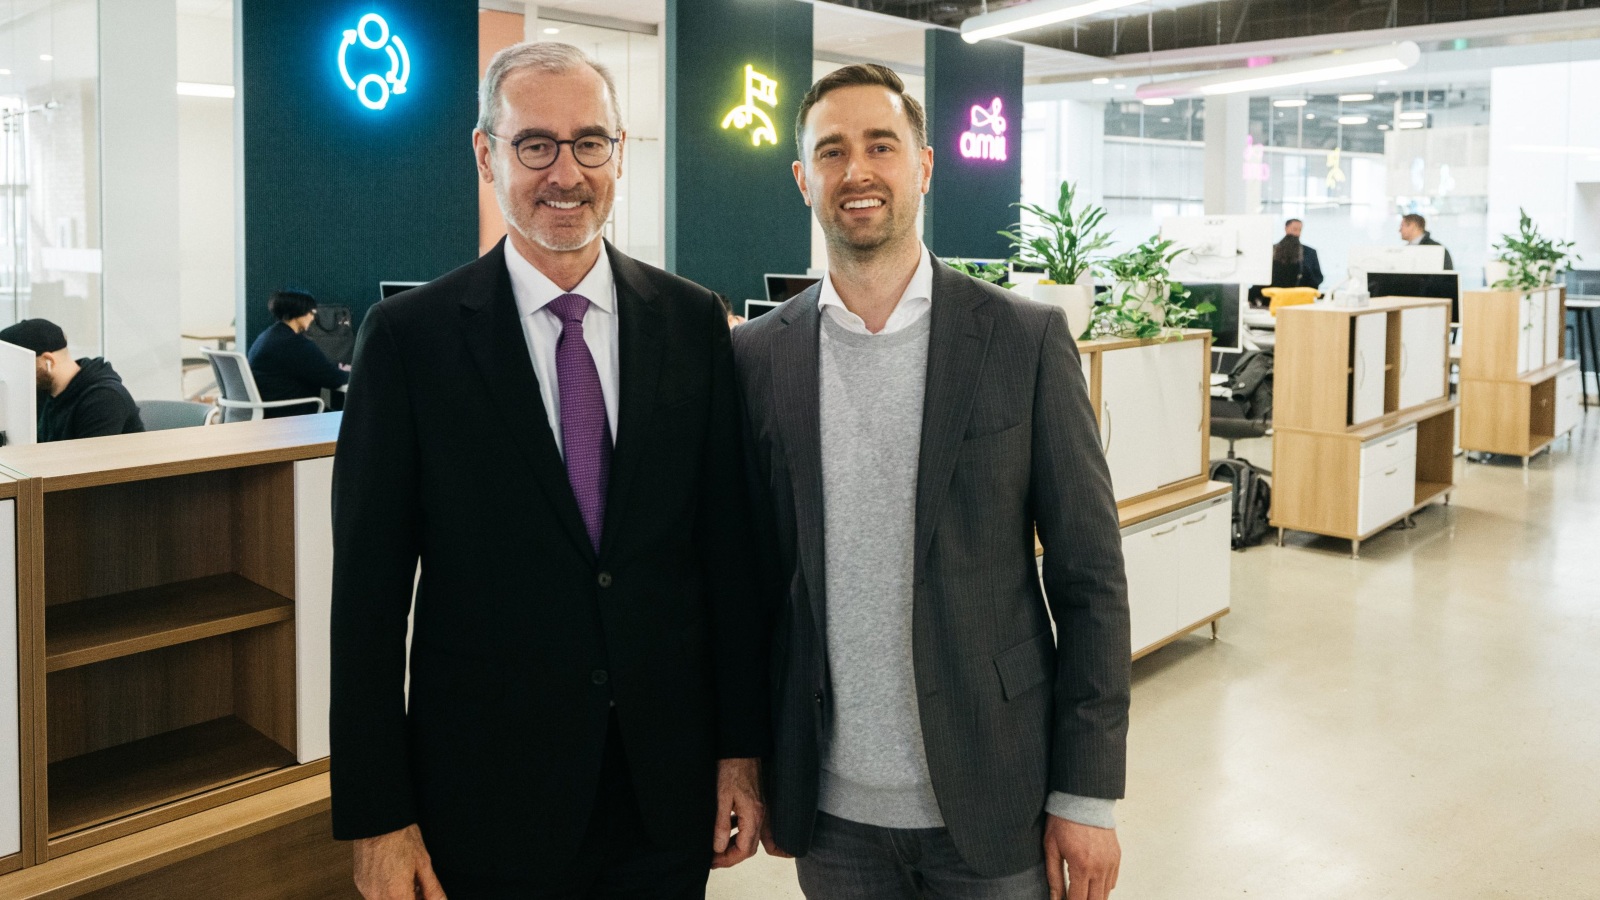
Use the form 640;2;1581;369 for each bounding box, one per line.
506;240;619;458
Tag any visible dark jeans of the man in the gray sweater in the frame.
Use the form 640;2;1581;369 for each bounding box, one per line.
795;812;1050;900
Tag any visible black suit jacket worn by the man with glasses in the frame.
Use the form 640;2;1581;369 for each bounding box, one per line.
331;243;770;876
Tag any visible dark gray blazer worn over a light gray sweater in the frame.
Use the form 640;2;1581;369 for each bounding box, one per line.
733;254;1131;876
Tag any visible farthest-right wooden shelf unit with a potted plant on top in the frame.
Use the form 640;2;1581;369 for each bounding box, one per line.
1461;287;1582;466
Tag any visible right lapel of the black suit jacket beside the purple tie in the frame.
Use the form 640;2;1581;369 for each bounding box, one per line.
601;243;662;556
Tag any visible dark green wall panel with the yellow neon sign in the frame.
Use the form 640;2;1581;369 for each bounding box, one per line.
664;0;811;309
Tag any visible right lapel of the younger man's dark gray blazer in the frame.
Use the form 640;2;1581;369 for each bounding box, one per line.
915;259;994;560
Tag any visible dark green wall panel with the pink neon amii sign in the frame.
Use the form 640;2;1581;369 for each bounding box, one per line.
923;29;1022;259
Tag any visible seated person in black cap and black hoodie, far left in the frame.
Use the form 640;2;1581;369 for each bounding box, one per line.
0;319;144;444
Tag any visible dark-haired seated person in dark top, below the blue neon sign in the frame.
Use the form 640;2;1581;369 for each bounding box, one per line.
250;290;350;418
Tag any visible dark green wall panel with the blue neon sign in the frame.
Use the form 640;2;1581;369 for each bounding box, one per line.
237;0;478;346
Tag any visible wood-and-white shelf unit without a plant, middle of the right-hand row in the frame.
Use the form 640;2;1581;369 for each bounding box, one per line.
1272;298;1456;557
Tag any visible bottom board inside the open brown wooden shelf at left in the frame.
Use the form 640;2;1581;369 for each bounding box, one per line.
50;716;294;838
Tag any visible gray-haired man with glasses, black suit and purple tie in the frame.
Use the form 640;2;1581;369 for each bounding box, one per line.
331;43;770;900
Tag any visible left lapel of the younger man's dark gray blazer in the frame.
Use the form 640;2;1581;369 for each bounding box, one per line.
773;285;827;634
